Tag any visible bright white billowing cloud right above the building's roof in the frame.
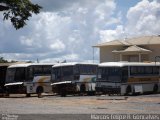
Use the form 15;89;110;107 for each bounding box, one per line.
100;0;160;42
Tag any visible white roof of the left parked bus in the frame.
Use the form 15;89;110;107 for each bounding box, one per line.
8;63;56;68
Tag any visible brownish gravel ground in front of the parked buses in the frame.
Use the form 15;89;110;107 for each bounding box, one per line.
0;94;160;119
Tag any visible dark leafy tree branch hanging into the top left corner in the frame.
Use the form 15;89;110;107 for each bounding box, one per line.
0;0;42;29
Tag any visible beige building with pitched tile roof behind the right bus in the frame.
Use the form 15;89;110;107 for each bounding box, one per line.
93;35;160;62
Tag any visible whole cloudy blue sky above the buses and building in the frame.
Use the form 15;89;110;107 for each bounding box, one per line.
0;0;160;62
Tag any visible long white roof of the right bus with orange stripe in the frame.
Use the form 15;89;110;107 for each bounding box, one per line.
98;62;160;67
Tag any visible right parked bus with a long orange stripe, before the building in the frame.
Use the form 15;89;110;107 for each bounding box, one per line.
96;62;160;95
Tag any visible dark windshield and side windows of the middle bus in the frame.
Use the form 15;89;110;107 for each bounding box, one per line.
52;64;97;82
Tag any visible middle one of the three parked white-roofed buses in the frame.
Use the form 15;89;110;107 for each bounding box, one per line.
51;63;98;97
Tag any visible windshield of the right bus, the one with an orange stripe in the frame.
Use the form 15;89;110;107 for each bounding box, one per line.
98;67;122;82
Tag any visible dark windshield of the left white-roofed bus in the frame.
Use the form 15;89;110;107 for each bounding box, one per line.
6;67;25;83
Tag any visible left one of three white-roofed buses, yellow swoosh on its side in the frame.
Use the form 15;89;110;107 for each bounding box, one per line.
5;63;54;97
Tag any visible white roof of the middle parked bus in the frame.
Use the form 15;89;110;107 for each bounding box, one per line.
52;62;98;68
